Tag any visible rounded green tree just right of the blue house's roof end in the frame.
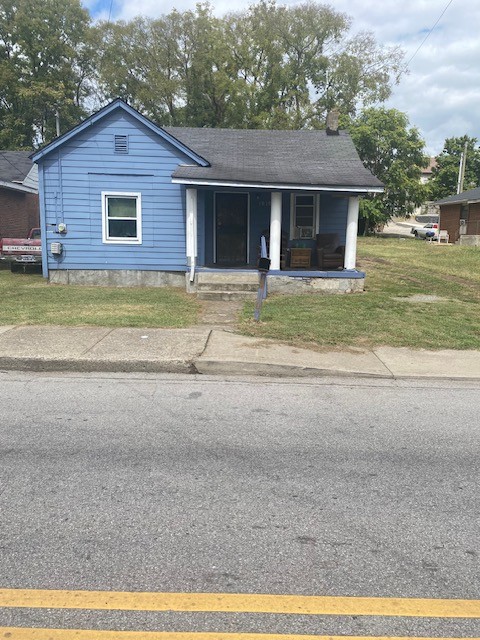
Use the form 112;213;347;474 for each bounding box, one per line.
348;107;428;232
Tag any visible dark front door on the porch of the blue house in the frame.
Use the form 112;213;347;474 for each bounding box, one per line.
215;193;248;267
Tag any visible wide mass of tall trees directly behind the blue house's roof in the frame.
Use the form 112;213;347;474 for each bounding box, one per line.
95;0;402;129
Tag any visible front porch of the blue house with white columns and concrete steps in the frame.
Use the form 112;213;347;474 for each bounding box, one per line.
186;187;365;299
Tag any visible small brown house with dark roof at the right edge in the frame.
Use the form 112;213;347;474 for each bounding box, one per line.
434;187;480;246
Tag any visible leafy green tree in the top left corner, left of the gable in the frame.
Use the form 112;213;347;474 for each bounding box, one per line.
0;0;93;148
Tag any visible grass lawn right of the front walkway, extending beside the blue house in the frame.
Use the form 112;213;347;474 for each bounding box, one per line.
241;238;480;349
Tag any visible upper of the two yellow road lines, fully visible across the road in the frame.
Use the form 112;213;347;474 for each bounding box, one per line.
0;589;480;618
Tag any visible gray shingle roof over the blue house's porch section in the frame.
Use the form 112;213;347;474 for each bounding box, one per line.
165;127;382;190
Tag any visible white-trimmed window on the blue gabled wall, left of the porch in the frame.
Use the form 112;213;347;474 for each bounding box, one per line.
102;191;142;244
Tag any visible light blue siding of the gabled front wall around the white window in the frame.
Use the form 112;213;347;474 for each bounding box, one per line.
39;110;193;271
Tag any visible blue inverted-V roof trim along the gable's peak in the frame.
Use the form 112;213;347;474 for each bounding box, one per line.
31;99;209;167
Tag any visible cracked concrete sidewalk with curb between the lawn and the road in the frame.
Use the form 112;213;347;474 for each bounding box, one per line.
0;326;480;380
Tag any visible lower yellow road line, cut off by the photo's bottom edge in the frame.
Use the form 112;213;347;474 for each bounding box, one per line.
0;627;478;640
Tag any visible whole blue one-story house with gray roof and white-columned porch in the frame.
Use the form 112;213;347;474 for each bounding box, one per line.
32;100;383;291
